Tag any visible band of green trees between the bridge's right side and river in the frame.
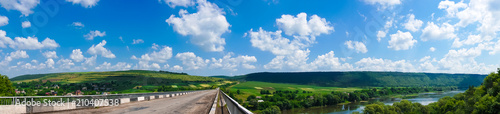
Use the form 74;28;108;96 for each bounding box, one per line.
229;87;457;113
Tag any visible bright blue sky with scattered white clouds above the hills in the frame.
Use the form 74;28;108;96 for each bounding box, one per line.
0;0;500;77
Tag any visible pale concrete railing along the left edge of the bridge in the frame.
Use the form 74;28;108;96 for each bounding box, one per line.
0;90;205;114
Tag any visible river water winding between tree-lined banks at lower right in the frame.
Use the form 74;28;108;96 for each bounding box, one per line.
282;91;464;114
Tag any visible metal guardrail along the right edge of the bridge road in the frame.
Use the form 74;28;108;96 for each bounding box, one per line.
220;91;253;114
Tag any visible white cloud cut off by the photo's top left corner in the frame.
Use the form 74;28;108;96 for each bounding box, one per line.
0;0;40;16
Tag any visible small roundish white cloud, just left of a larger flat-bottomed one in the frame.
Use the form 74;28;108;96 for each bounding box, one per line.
387;30;417;51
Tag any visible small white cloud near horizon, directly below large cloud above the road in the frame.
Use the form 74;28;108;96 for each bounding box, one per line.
175;52;210;70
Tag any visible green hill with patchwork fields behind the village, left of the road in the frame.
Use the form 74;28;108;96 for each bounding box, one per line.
10;70;227;93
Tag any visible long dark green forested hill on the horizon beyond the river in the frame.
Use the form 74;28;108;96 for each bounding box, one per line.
240;71;486;88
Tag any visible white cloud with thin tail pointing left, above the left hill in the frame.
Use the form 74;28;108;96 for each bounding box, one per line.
132;46;172;63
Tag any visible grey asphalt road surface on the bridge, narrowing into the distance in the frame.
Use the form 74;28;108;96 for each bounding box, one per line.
48;90;217;114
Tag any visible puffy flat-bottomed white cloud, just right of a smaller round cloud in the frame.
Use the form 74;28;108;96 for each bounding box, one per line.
420;22;457;42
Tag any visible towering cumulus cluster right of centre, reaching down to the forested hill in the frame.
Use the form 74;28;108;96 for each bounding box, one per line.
247;13;340;70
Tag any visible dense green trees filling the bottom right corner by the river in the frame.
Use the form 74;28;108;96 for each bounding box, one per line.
363;68;500;114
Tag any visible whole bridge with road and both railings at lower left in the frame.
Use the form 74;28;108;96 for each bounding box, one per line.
0;89;252;114
